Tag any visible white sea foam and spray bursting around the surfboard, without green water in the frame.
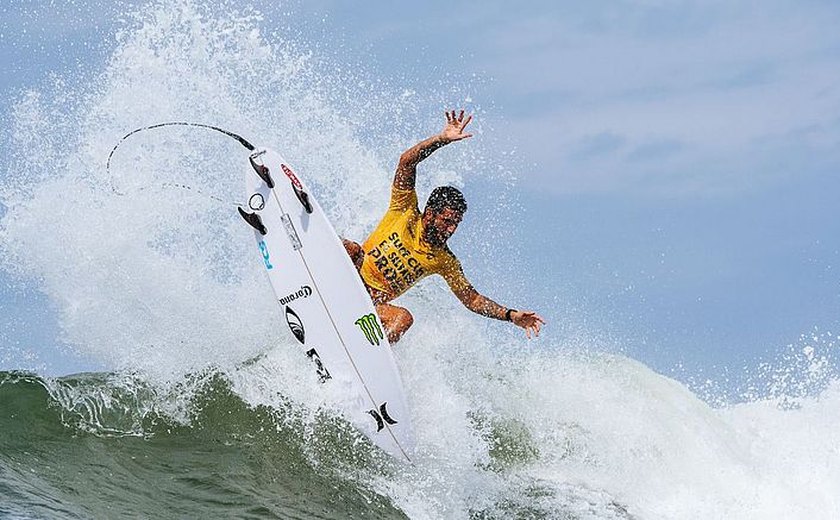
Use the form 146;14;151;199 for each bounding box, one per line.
0;0;840;519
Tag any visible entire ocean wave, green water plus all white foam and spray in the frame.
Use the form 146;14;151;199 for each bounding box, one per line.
0;0;840;520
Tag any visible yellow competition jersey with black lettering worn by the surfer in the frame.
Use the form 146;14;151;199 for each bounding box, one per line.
361;187;470;300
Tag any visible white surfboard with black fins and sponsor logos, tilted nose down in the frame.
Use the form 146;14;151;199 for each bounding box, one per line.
240;148;414;462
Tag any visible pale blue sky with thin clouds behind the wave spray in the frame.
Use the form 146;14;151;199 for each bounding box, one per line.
0;0;840;396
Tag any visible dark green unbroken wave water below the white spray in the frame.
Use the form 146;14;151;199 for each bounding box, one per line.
0;373;405;519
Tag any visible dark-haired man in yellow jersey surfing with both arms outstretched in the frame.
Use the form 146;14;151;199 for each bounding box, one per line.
344;110;545;344
